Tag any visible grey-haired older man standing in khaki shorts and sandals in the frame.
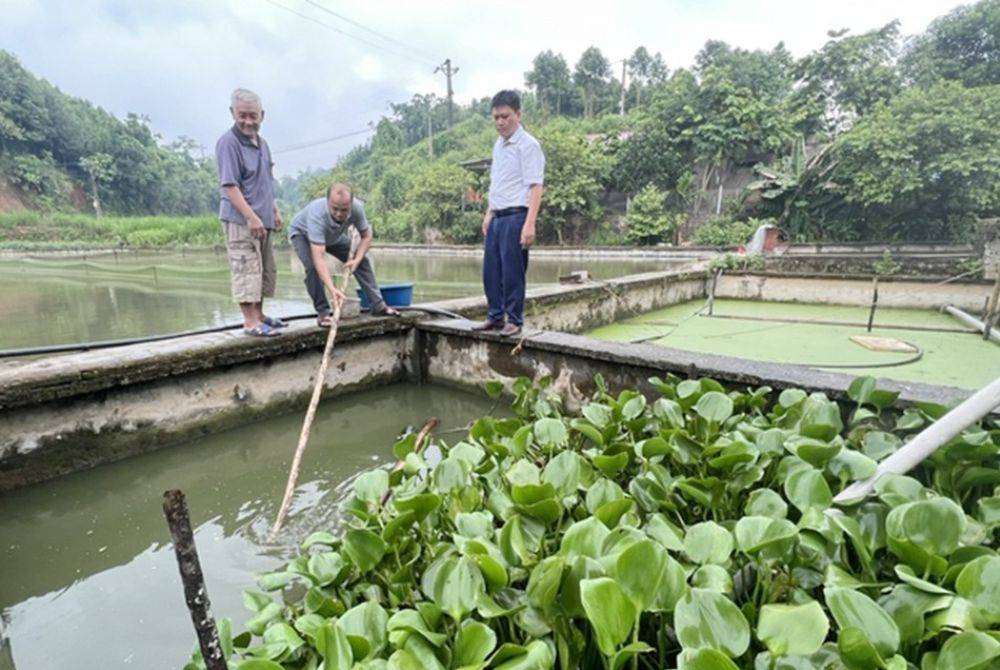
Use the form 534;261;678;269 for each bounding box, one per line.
215;88;286;337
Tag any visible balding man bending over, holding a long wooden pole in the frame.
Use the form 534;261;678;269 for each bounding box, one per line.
288;183;399;328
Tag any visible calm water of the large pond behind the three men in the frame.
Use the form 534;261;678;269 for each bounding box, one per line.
0;249;666;348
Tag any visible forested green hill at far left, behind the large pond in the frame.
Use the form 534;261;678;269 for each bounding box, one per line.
0;51;218;215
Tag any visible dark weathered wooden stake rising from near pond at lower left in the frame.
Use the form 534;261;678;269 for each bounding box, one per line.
163;490;226;670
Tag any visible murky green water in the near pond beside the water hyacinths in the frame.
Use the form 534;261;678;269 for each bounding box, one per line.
0;384;500;670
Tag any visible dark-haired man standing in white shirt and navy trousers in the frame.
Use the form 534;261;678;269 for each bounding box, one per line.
472;91;545;337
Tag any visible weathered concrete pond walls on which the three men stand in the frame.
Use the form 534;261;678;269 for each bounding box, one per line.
0;268;986;491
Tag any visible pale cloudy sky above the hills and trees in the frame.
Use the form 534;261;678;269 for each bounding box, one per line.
0;0;965;175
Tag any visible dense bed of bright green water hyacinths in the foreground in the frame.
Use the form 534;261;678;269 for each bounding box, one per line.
187;377;1000;670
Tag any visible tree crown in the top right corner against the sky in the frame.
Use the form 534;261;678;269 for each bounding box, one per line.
901;0;1000;86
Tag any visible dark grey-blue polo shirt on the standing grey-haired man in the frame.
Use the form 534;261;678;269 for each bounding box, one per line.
215;126;274;230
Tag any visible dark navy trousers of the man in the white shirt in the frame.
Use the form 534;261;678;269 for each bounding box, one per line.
483;212;528;326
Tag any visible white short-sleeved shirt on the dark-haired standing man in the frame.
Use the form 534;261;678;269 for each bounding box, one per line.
490;128;545;209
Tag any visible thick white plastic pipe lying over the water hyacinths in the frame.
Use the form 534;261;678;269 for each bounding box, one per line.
833;378;1000;504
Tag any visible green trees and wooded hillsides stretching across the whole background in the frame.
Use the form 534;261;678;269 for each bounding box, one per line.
0;0;1000;244
